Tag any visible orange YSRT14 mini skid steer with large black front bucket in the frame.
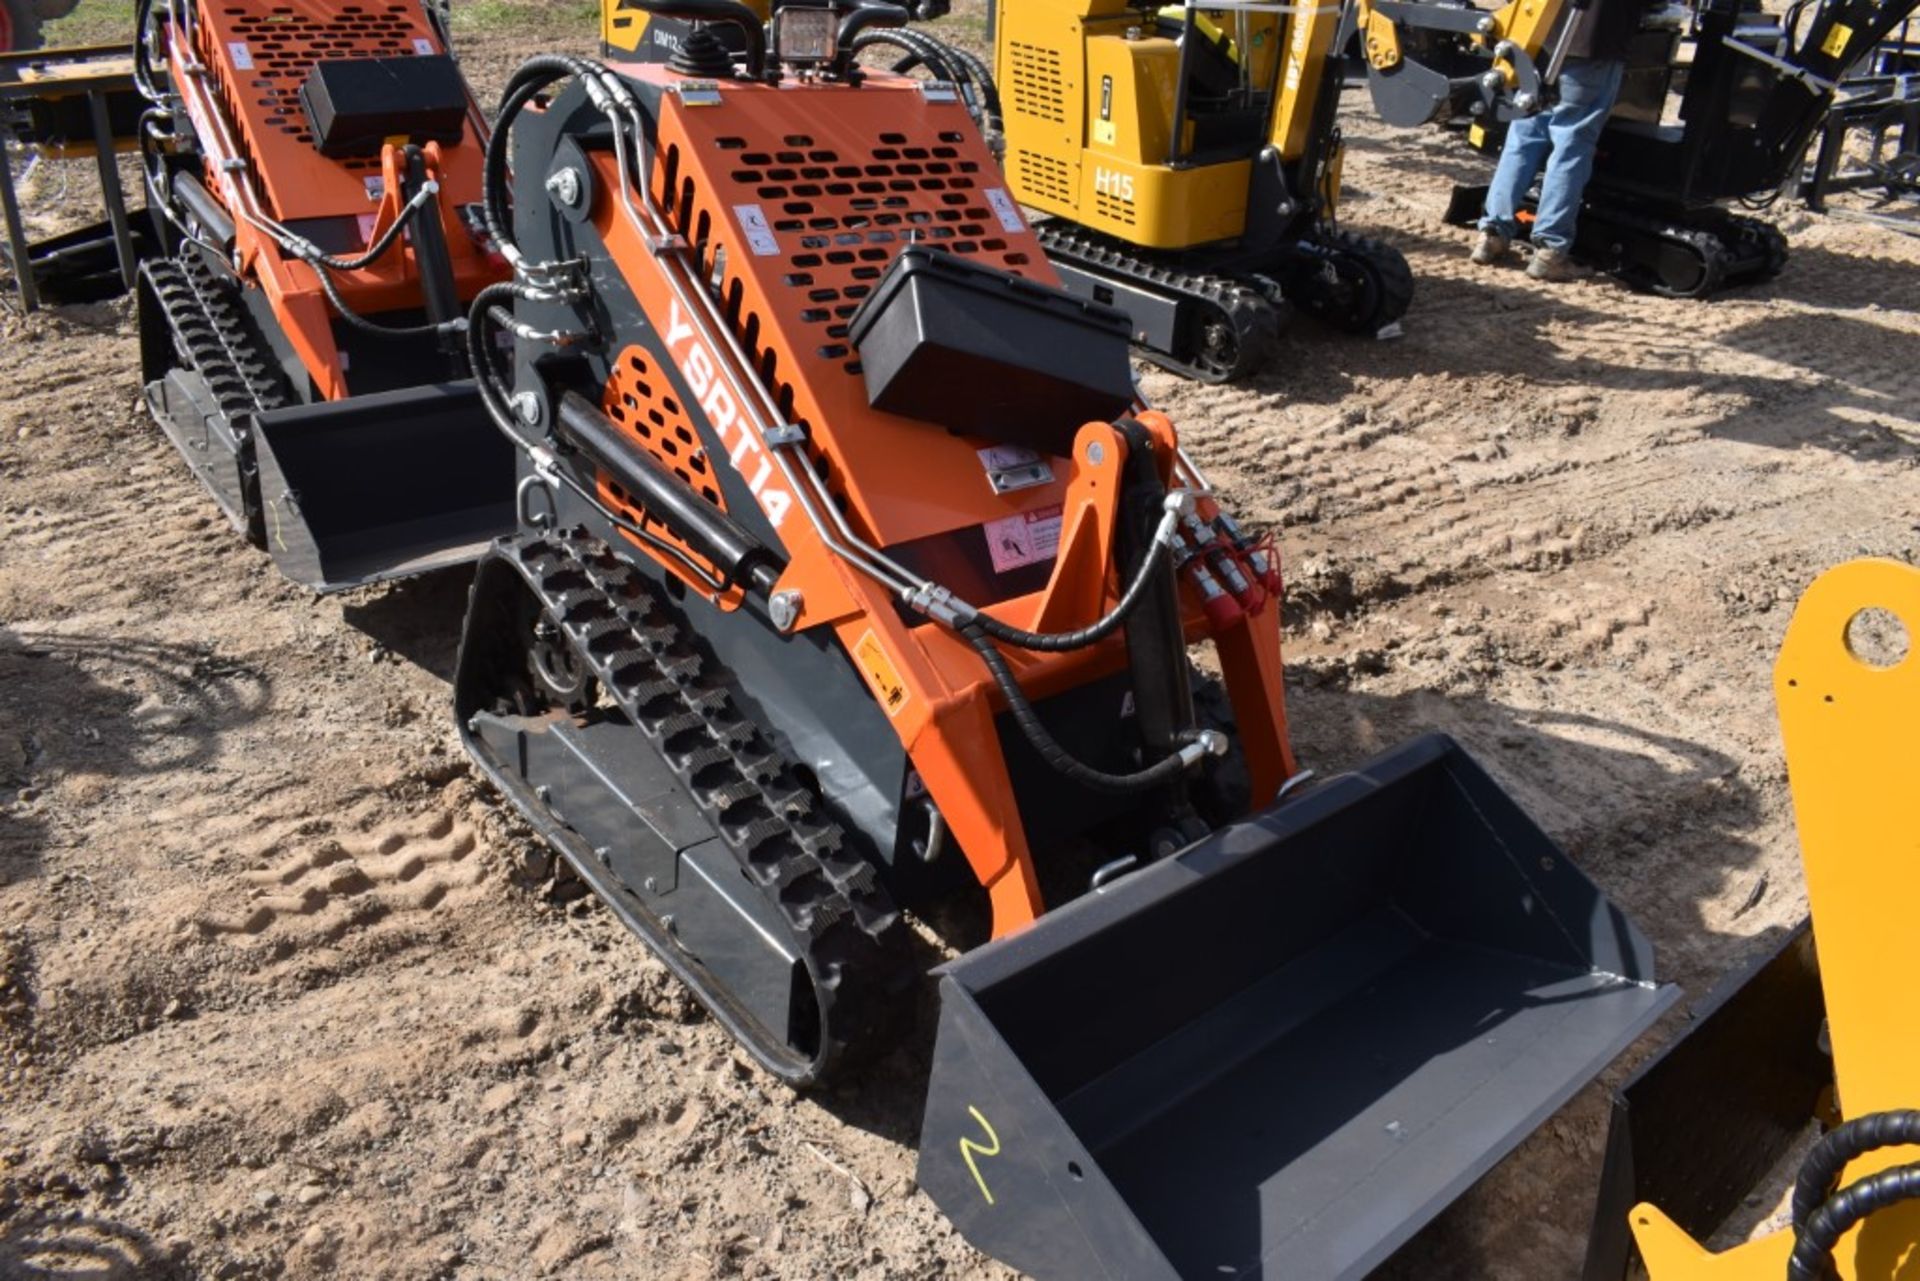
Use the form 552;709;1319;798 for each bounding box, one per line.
455;0;1670;1281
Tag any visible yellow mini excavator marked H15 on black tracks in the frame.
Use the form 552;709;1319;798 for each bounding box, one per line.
989;0;1413;382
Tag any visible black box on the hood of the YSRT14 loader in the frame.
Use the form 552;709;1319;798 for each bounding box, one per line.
849;246;1133;457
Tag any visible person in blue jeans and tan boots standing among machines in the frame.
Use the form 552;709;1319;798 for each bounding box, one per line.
1473;0;1645;280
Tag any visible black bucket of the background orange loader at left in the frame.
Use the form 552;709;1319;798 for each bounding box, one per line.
253;382;515;592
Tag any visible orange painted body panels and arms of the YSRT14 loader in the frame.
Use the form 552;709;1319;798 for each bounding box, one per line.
591;67;1294;935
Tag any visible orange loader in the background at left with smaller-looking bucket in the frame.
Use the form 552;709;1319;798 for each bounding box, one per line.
134;0;513;590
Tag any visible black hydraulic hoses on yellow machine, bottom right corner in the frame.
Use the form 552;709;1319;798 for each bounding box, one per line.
1788;1110;1920;1281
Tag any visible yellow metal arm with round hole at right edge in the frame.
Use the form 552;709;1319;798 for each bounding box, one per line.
1632;561;1920;1281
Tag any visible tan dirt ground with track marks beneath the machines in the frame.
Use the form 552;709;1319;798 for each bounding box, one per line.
0;5;1920;1281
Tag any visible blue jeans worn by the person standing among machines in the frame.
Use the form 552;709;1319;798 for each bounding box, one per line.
1480;58;1626;250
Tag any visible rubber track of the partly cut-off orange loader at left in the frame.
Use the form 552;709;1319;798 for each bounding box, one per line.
140;254;290;547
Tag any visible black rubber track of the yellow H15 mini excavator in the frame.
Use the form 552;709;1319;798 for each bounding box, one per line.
1035;219;1284;382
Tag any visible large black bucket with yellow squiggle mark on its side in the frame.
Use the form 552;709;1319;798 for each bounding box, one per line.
920;736;1676;1281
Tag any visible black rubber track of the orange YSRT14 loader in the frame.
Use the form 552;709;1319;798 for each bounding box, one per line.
455;530;904;1085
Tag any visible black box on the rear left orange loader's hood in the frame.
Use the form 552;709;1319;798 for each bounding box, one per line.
300;54;467;159
